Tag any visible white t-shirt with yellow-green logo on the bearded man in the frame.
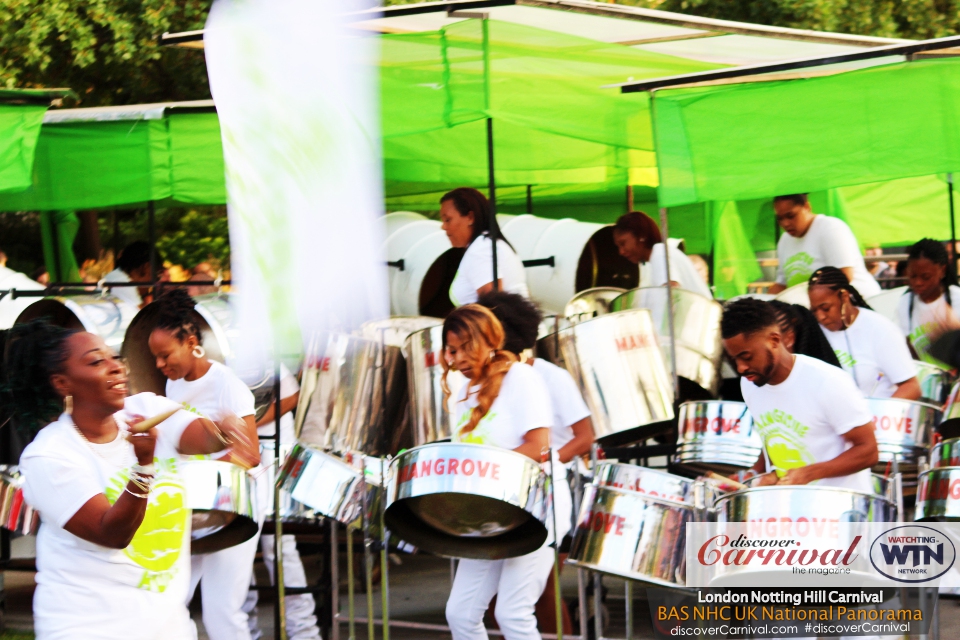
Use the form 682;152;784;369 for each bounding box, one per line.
740;354;873;493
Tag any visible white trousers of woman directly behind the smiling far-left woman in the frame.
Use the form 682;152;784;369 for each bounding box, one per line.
187;524;260;640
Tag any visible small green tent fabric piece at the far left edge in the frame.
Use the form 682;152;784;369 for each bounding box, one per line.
0;104;47;193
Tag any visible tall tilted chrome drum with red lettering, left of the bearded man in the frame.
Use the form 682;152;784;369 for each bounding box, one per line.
559;309;674;443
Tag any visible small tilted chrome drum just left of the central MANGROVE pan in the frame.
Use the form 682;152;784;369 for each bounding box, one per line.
277;443;383;524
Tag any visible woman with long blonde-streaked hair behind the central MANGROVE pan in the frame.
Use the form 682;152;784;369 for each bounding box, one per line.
443;304;570;640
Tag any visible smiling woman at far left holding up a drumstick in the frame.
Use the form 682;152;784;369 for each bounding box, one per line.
3;322;257;640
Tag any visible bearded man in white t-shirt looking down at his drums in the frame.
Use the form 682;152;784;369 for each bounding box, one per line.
721;298;878;493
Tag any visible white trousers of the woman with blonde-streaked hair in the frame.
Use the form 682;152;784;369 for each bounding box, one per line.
447;545;553;640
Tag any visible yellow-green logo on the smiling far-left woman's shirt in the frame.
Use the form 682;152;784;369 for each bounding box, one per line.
105;458;190;593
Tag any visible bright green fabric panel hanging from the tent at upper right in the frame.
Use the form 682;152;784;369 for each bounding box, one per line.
653;58;960;207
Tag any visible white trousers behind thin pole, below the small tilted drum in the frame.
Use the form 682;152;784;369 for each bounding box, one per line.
243;534;320;640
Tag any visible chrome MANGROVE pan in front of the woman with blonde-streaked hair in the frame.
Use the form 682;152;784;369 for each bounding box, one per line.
386;443;547;560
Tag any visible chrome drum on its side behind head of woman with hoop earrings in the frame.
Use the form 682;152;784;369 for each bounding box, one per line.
120;293;274;418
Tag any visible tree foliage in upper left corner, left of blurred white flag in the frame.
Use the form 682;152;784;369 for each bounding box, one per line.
0;0;212;107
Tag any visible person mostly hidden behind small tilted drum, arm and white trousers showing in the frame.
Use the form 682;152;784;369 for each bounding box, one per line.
243;365;320;640
